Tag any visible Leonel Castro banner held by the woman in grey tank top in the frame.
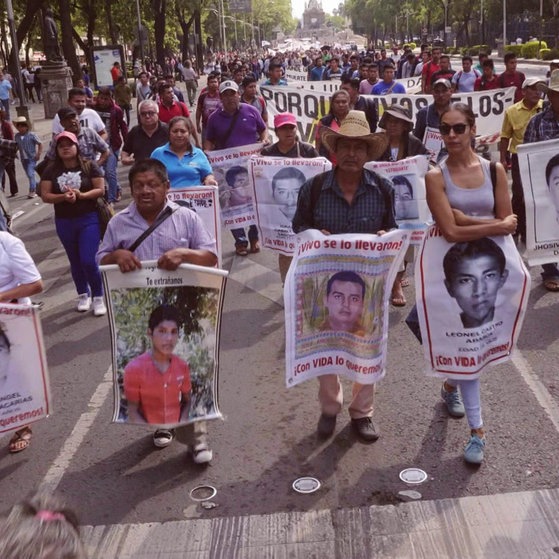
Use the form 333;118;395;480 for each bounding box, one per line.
415;225;530;379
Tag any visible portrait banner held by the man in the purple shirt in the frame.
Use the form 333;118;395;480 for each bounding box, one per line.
207;143;264;233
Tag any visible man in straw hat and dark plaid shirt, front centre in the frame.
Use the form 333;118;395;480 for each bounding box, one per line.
293;111;397;442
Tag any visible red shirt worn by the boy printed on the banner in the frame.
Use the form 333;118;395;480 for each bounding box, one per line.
124;352;192;425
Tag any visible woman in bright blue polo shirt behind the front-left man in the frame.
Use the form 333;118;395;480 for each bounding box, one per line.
151;116;217;188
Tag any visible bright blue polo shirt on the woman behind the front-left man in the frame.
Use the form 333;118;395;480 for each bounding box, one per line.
151;142;212;188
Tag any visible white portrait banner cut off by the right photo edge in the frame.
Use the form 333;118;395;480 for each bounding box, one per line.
518;140;559;266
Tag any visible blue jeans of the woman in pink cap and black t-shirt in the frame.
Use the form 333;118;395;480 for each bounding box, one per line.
55;212;103;297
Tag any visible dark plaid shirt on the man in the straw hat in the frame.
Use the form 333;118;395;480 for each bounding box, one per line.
293;170;398;235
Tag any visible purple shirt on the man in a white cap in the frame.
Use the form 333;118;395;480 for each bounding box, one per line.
206;103;266;149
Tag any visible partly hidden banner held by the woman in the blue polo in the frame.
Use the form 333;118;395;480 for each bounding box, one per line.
167;186;221;268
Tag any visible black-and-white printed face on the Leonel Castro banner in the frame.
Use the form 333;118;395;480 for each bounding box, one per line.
443;237;509;328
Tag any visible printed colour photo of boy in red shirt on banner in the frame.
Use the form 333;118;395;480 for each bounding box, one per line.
111;286;219;426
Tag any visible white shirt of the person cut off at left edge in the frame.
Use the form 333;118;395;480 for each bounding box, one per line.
0;231;41;305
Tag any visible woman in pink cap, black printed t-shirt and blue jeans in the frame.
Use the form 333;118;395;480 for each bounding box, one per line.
40;132;107;316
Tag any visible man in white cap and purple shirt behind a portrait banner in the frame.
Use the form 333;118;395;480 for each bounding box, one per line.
204;80;268;256
